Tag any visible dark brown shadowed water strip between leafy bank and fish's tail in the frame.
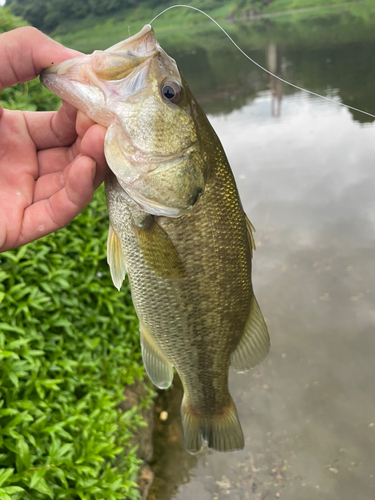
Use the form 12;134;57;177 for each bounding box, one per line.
148;375;197;500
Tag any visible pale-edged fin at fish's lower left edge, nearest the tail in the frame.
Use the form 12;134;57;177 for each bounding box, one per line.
140;325;173;389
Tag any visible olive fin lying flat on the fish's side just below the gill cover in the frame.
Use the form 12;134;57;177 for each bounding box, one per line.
133;215;184;279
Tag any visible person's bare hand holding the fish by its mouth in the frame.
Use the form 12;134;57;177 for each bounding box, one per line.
0;27;108;252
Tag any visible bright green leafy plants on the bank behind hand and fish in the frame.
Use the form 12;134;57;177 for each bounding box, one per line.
0;8;151;500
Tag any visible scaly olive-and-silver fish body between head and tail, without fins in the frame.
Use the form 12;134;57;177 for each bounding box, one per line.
107;138;252;414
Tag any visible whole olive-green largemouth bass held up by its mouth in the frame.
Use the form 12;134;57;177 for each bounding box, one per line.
40;25;270;454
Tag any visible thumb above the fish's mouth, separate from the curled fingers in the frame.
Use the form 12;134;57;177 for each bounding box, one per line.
0;26;81;90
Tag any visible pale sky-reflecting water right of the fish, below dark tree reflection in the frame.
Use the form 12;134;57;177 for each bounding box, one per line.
173;92;375;500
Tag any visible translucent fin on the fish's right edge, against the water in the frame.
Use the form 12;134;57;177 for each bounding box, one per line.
230;296;270;372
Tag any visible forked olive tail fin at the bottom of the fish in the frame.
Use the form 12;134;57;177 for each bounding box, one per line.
181;396;244;454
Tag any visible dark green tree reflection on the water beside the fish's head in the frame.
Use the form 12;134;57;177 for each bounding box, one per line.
168;36;375;123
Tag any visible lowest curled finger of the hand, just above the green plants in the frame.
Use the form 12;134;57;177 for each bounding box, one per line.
15;156;96;246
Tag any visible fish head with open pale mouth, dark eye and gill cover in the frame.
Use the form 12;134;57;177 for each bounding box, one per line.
41;25;209;217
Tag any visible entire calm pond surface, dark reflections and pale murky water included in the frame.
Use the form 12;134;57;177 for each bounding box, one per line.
145;8;375;500
